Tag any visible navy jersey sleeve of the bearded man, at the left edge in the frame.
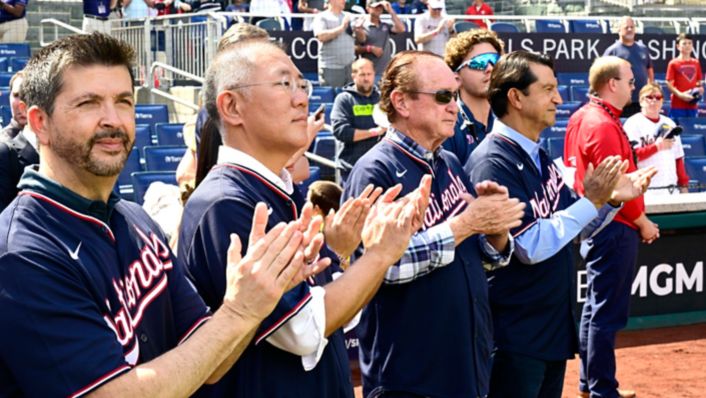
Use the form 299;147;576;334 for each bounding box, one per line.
0;253;130;397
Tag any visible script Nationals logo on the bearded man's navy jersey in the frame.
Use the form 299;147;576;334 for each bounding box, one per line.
103;226;172;365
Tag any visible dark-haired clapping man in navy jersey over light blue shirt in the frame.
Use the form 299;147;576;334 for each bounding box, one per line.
465;51;656;398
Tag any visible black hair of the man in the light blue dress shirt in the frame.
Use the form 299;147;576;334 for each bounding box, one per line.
488;51;554;118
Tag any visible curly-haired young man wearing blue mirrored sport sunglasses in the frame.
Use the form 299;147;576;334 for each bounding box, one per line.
443;29;503;164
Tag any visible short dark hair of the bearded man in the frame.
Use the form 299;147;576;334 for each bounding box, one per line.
20;33;135;115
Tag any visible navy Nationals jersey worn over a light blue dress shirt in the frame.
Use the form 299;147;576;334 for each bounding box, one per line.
466;134;577;361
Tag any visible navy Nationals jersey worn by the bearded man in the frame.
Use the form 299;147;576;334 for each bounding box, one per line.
0;169;209;397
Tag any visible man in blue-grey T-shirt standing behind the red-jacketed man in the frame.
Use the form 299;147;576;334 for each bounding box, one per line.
603;16;655;117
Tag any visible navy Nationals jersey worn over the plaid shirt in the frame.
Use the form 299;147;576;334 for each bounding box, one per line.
342;131;492;397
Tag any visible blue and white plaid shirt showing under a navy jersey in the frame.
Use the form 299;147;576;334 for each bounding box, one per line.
384;129;514;284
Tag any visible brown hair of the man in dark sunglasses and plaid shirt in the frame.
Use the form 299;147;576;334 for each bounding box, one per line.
380;51;441;122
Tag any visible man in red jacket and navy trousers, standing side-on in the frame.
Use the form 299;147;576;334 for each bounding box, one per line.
564;56;659;397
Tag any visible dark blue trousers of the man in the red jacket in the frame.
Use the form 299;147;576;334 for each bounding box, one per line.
579;221;639;398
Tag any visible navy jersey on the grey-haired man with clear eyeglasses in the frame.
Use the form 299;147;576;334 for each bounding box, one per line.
179;163;353;397
